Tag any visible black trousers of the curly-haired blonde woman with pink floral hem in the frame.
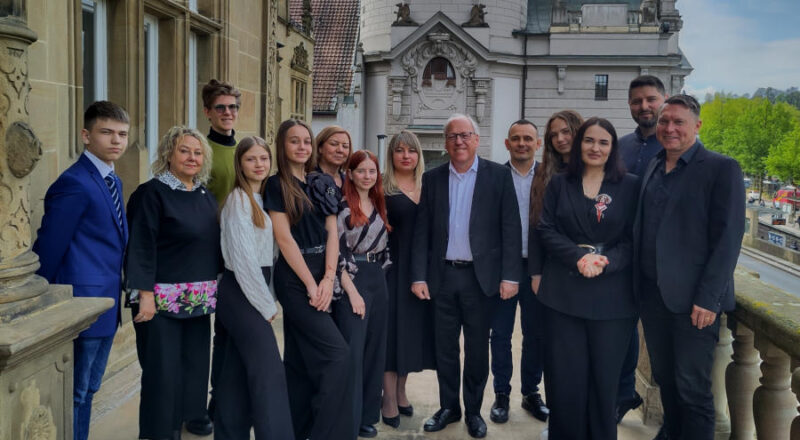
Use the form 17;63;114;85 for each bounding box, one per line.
131;304;211;439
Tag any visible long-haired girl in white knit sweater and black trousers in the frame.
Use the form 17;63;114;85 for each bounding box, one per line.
214;136;294;440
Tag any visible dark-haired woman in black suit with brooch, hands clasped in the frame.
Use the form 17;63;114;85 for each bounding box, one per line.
538;118;639;439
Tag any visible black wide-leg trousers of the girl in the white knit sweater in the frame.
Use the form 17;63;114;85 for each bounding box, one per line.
214;267;294;440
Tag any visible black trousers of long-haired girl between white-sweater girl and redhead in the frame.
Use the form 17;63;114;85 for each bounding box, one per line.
274;254;356;440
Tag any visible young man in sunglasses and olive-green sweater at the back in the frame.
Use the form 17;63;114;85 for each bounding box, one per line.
203;79;242;206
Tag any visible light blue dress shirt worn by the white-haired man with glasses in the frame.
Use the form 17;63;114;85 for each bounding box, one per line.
445;155;478;261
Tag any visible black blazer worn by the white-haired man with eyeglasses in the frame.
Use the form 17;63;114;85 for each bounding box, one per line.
411;159;527;296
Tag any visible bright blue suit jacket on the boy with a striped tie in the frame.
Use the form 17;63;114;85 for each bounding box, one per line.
33;154;128;337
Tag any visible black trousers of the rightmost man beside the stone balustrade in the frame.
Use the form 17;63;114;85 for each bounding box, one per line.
641;279;720;440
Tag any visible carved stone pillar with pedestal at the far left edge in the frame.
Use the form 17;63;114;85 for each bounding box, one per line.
0;10;113;440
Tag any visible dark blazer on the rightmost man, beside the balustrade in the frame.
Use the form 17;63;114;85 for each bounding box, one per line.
633;142;745;313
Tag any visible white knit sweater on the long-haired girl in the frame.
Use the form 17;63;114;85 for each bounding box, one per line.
220;188;278;320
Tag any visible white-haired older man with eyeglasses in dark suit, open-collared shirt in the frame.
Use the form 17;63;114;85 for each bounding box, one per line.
411;114;527;438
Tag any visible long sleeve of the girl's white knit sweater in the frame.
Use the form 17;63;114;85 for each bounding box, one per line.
222;189;278;320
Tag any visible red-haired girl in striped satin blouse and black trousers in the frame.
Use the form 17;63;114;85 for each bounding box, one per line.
333;150;391;437
